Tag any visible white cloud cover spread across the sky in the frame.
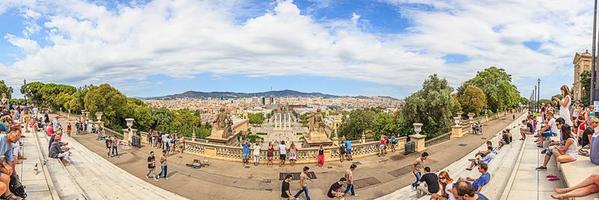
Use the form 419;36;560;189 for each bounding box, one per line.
0;0;592;97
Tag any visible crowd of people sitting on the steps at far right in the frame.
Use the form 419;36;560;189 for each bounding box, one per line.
521;85;599;199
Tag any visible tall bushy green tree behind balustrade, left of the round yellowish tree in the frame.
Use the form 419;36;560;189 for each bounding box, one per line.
401;74;453;138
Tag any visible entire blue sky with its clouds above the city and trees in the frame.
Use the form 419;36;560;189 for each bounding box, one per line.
0;0;592;98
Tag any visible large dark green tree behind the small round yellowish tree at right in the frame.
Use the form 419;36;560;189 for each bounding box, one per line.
458;67;520;112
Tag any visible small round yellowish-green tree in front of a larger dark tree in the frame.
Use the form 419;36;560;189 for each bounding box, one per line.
458;85;487;115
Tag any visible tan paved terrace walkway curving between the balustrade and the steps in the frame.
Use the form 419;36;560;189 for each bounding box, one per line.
64;111;520;199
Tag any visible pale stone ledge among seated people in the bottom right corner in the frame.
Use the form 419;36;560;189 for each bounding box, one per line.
557;156;599;200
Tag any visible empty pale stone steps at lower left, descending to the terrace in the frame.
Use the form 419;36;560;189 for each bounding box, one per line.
36;129;185;200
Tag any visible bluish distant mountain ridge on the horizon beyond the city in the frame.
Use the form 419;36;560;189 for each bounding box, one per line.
146;90;340;100
